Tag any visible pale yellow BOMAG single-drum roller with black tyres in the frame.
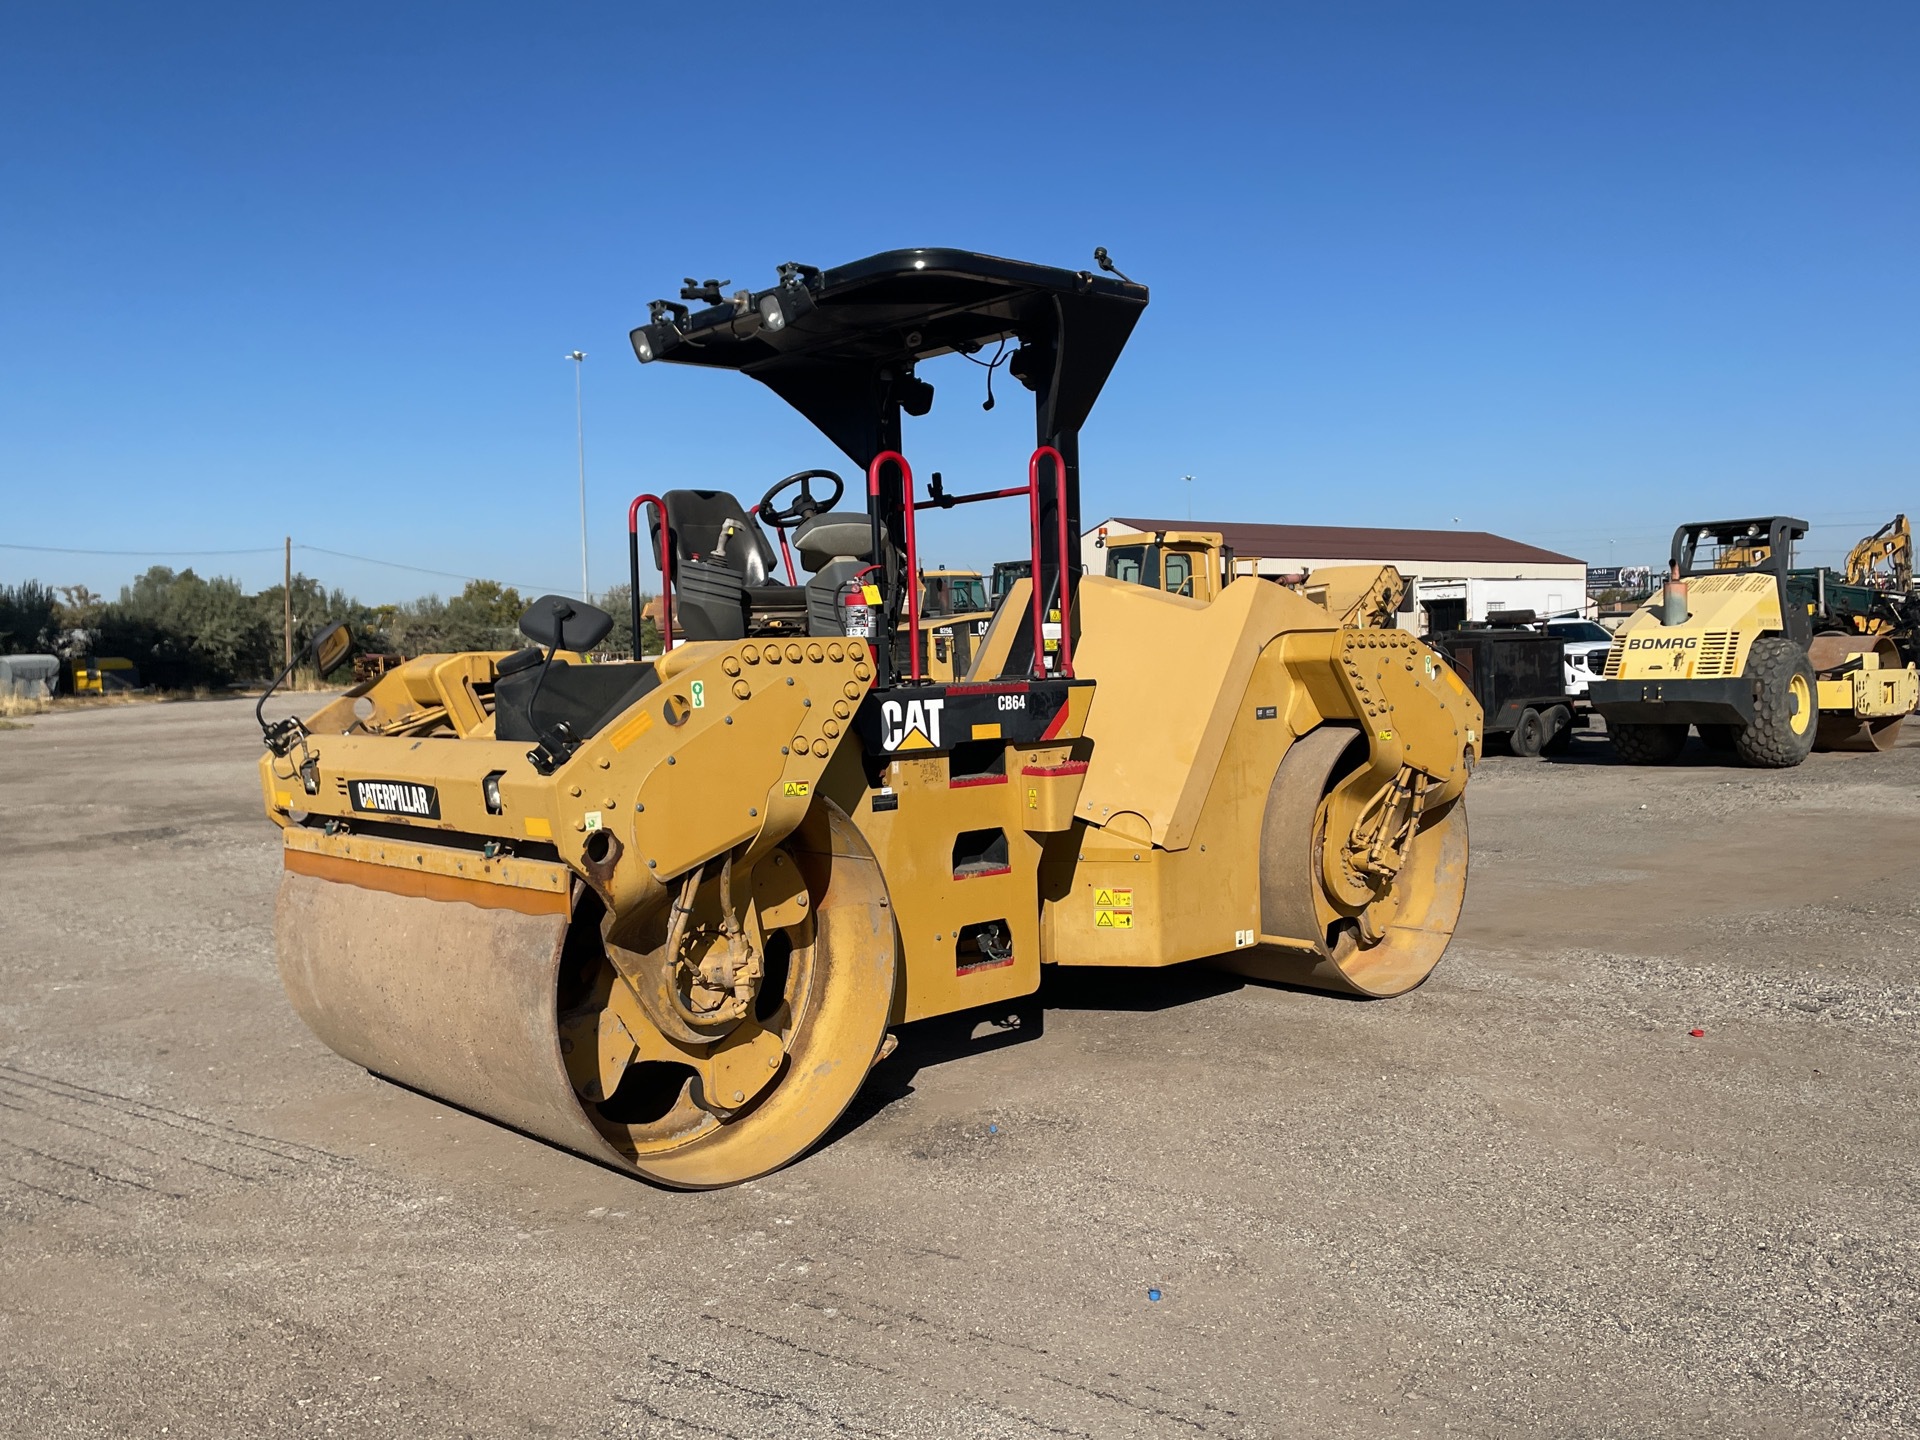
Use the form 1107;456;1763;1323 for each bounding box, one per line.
1588;515;1920;770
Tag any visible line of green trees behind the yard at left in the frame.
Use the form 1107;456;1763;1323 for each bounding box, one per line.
0;564;660;689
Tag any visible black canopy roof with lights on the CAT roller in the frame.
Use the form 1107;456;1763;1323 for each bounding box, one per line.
632;250;1146;467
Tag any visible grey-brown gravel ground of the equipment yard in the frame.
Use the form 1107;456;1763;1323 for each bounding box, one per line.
0;701;1920;1440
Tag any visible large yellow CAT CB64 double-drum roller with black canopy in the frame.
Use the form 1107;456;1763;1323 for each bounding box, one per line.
261;250;1480;1187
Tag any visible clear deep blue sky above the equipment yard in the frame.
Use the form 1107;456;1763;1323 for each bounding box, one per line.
0;0;1920;599
